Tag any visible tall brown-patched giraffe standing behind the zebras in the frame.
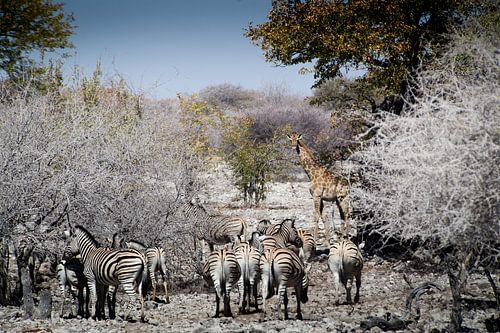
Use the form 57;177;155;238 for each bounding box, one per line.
288;133;349;242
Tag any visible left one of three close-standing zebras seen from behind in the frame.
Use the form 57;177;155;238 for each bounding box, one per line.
203;248;241;318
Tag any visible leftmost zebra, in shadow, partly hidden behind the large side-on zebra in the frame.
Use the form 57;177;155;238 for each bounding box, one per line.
57;258;90;318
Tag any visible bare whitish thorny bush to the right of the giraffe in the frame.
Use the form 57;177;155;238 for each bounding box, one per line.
353;21;500;330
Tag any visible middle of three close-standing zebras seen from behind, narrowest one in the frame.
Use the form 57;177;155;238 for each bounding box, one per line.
234;242;261;313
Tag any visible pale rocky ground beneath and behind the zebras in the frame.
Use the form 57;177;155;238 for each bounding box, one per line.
0;171;498;332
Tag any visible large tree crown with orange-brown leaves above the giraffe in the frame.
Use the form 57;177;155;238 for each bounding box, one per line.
246;0;488;102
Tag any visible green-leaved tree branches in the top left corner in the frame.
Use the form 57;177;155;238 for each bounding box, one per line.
0;0;74;76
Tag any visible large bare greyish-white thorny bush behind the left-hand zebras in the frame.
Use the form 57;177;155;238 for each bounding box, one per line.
0;83;207;300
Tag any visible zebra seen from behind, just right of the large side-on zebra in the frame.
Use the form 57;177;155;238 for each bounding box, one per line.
125;240;170;303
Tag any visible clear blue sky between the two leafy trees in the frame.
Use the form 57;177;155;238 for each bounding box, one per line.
60;0;314;98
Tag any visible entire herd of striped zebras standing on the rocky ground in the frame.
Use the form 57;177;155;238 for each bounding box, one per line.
57;203;363;321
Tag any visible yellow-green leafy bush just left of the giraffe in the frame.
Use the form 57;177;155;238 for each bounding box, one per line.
221;117;289;204
